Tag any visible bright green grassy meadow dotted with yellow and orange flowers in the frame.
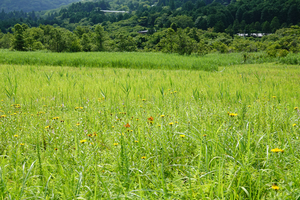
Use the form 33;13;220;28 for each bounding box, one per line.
0;52;300;199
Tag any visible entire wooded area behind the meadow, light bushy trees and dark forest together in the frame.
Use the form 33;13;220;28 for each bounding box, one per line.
0;0;300;55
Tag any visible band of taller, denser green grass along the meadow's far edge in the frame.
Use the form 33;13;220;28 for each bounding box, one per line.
0;50;248;71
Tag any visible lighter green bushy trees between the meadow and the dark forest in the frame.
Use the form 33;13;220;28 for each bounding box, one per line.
0;23;300;56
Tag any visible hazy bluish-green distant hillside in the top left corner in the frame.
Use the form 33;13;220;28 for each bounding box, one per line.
0;0;80;12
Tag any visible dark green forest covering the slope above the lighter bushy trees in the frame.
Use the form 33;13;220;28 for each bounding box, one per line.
0;0;300;35
